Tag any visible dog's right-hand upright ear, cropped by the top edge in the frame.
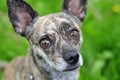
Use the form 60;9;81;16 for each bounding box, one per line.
63;0;87;21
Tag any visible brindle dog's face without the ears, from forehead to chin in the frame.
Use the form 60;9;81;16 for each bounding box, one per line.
29;12;82;71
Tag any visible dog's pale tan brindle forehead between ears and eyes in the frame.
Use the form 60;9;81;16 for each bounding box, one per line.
34;13;79;34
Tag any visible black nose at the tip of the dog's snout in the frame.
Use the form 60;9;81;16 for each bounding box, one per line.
63;50;79;65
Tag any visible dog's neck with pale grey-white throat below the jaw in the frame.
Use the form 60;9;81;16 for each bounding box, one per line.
27;48;79;80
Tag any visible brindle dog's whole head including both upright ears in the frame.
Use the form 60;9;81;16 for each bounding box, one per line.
7;0;87;71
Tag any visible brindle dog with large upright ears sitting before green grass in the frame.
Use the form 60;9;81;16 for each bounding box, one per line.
3;0;87;80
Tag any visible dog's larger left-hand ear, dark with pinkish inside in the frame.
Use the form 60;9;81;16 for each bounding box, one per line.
7;0;38;36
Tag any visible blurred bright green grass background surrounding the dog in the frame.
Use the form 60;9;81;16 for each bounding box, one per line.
0;0;120;80
